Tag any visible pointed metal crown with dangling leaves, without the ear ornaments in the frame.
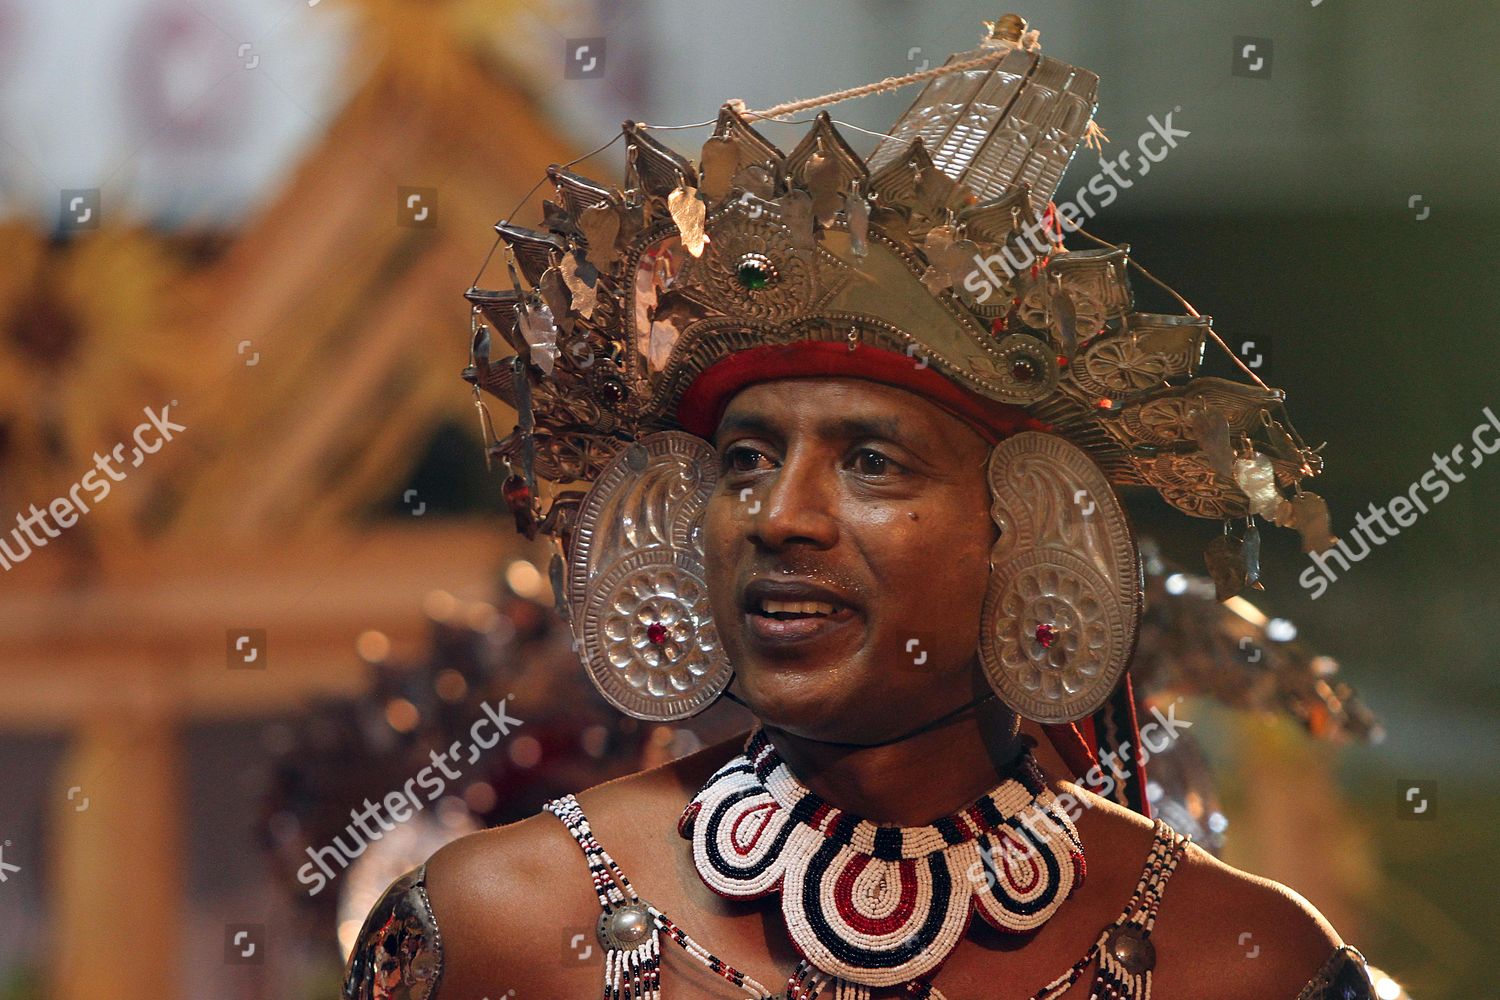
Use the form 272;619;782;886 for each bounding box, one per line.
465;18;1329;582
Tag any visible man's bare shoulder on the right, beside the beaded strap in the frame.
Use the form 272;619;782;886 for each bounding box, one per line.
1061;783;1343;1000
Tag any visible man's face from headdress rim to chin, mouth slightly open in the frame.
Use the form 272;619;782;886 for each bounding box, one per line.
704;378;996;742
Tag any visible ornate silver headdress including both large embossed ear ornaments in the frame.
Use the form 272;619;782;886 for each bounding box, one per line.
465;15;1331;721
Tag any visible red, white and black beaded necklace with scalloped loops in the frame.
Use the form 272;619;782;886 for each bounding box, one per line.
678;727;1085;997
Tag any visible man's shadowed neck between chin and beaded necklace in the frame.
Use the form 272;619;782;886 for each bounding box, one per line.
765;689;1025;826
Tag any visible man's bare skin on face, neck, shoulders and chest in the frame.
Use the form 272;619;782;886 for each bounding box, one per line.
354;379;1374;1000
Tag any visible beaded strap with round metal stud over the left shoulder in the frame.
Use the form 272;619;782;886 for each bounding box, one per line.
543;795;776;1000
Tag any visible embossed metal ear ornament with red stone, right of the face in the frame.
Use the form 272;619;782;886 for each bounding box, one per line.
980;430;1143;723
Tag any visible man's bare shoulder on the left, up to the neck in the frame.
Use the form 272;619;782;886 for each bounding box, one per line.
426;731;738;1000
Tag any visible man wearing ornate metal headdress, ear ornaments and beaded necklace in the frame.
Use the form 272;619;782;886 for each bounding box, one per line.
345;19;1373;1000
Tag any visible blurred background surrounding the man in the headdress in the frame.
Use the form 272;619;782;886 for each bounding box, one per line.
0;0;1500;1000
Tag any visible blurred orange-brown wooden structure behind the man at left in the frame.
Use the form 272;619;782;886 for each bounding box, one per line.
0;0;575;1000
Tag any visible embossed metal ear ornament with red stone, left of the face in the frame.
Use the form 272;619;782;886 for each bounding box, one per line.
567;430;734;721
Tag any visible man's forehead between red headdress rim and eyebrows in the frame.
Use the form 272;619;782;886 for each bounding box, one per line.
716;376;974;444
